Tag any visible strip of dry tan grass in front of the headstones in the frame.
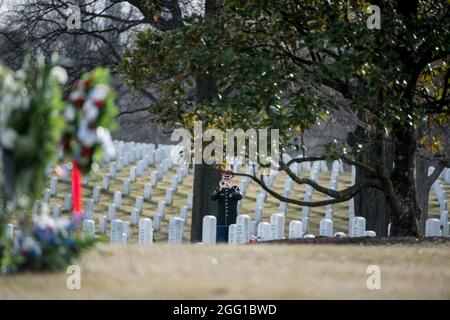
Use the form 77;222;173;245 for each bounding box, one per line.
0;242;450;299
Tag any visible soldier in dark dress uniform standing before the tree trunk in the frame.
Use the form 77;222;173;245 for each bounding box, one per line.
211;170;242;242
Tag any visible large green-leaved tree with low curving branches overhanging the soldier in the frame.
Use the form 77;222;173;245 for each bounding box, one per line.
121;0;450;234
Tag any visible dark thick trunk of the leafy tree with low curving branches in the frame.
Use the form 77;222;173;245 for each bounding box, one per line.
389;126;422;236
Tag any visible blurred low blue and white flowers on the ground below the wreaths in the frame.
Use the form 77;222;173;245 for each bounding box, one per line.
1;214;98;273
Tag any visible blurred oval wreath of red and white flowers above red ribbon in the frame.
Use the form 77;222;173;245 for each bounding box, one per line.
62;68;117;173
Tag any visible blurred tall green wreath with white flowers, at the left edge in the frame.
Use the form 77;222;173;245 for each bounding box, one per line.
0;55;67;205
